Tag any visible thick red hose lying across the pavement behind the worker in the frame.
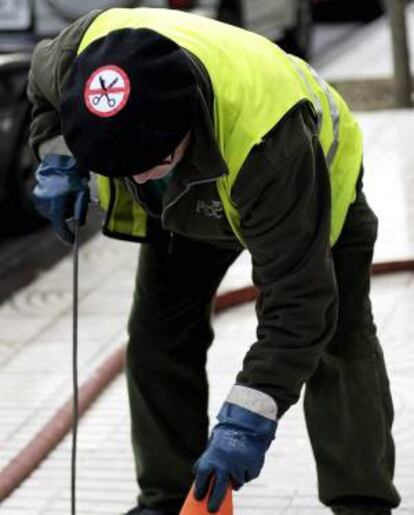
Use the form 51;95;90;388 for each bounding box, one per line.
0;260;414;501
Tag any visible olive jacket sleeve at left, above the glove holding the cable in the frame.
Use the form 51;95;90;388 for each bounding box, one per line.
27;10;100;158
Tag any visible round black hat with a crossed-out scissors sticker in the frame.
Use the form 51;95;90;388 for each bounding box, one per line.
60;29;196;177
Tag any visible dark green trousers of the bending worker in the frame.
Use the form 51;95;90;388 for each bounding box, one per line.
127;193;399;515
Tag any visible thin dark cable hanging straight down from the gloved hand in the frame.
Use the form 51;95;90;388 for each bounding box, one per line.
71;224;79;515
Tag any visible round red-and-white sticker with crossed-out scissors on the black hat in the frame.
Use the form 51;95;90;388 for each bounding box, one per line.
84;64;131;118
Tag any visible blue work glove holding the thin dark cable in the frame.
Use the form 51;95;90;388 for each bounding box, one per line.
33;154;90;245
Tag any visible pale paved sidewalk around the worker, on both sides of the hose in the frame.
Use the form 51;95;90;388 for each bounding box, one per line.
0;6;414;515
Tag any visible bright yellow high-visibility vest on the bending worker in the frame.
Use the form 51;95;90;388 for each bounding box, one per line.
78;8;362;243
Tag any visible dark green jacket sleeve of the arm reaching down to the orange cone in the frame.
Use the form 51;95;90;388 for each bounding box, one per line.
232;107;337;417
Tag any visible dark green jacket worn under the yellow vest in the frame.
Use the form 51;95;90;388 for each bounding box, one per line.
28;11;337;414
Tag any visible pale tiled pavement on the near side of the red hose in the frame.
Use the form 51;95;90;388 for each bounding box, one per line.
1;242;414;515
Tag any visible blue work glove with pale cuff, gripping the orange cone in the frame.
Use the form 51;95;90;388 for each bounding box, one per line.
194;385;277;513
